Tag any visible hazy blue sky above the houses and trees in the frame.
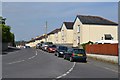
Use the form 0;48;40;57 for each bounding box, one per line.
2;2;118;41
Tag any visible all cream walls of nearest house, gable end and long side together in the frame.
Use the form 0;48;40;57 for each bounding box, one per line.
73;18;118;47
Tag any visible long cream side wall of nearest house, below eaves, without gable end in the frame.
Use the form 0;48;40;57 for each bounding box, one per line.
80;25;118;44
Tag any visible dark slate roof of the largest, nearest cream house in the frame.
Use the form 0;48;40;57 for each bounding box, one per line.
77;15;118;25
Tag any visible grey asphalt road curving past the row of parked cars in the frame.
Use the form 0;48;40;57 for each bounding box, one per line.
2;48;118;79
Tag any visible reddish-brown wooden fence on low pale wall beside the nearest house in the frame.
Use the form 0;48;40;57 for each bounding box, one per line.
85;44;118;56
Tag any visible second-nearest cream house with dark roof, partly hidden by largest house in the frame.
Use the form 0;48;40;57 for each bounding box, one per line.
61;22;73;44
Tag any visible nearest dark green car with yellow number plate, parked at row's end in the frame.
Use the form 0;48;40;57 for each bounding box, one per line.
64;48;87;62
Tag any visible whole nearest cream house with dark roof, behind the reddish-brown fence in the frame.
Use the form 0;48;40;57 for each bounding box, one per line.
73;15;118;47
